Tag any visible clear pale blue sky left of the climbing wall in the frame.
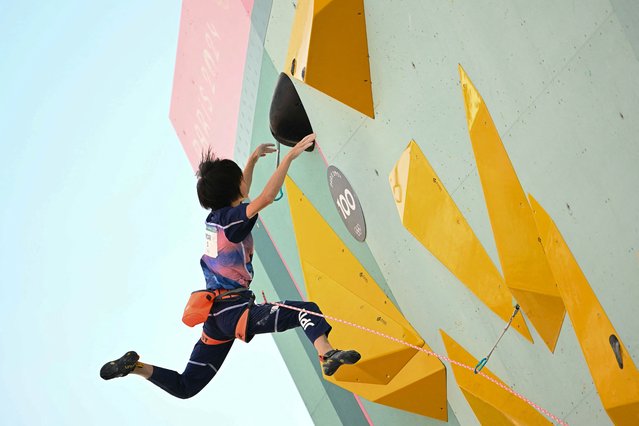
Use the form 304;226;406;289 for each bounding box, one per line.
0;0;311;425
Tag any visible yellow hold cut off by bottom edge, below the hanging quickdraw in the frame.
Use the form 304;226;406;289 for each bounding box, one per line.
439;330;552;425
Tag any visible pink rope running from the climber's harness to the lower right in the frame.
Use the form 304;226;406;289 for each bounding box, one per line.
262;292;568;426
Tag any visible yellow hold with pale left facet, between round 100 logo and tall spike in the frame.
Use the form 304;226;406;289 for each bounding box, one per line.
389;141;532;342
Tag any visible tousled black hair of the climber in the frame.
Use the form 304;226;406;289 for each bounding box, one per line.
196;149;243;210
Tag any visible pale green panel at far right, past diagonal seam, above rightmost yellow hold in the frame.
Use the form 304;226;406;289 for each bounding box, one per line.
500;11;639;362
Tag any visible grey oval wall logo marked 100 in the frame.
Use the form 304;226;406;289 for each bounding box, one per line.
326;166;366;242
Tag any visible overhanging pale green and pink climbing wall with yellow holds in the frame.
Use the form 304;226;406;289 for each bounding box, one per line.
171;0;639;425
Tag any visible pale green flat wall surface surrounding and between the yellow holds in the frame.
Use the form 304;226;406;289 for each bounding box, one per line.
253;0;639;425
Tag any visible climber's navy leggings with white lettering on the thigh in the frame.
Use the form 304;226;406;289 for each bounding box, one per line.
149;300;331;399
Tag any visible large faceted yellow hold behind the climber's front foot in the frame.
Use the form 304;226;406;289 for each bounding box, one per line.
286;177;447;419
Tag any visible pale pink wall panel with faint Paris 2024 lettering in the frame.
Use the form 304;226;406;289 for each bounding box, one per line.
170;0;253;169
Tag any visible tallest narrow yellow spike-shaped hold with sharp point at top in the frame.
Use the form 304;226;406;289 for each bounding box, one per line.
459;65;566;351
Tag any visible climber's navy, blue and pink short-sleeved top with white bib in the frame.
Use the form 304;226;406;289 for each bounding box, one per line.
200;204;258;290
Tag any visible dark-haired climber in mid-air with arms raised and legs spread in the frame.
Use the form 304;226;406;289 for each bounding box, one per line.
100;133;360;398
